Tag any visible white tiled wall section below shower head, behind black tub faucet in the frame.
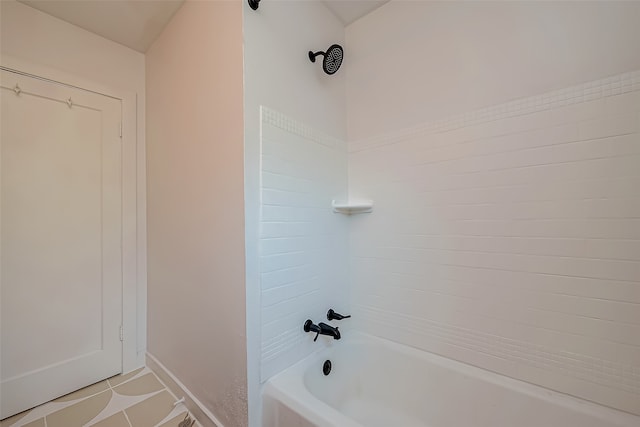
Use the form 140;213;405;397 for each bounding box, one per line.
260;107;349;381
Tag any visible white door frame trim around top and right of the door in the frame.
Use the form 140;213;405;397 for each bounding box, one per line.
0;54;147;373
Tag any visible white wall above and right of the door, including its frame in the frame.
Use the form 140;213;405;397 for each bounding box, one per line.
0;0;146;372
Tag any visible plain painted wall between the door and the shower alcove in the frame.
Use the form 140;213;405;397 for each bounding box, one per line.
146;1;247;427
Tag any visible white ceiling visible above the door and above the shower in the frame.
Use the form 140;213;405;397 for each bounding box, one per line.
18;0;389;53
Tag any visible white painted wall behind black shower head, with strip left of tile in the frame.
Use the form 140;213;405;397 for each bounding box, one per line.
243;0;349;426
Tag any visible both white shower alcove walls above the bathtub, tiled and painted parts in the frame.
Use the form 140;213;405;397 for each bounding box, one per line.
244;1;640;424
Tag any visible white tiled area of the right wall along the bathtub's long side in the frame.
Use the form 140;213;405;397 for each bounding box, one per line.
349;72;640;414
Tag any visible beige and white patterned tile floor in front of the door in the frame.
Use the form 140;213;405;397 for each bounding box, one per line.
0;368;199;427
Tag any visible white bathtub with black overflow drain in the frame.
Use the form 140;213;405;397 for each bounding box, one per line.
263;331;640;427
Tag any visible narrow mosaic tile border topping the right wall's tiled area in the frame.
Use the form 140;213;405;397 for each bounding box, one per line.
349;70;640;152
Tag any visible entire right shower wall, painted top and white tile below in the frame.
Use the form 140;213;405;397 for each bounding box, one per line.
347;1;640;414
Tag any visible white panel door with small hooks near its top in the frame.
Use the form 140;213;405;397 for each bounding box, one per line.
0;70;122;419
